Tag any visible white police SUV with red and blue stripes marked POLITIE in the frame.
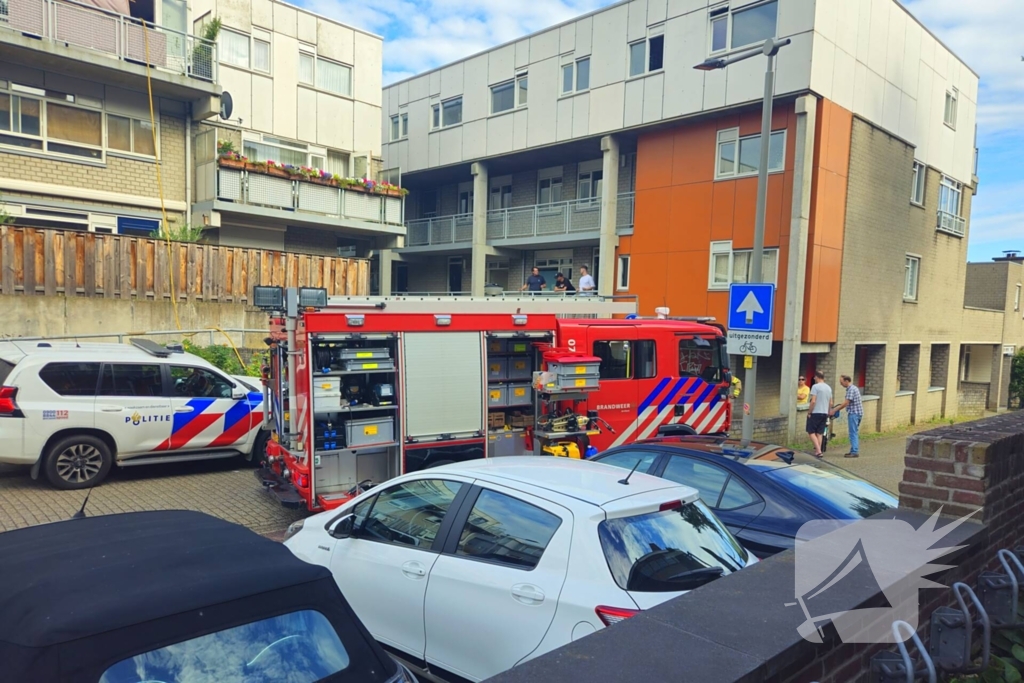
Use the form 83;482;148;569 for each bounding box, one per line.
0;339;269;488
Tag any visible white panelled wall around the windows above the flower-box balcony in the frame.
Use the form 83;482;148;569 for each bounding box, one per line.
190;0;383;157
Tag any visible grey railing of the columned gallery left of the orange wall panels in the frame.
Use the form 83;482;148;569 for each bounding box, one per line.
406;193;634;247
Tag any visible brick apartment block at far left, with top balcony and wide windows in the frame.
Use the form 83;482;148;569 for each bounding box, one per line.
0;0;221;236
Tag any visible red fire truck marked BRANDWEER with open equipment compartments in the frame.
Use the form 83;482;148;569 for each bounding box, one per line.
254;288;731;511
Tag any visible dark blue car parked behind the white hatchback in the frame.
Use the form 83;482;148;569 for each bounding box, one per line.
591;436;899;558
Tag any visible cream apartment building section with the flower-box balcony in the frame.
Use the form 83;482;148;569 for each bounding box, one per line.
191;0;406;256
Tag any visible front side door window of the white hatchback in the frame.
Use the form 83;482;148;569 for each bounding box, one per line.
358;479;462;550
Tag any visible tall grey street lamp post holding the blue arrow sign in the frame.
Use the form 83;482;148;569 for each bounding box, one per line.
694;38;793;446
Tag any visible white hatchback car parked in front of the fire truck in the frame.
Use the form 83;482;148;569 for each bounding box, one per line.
285;457;757;681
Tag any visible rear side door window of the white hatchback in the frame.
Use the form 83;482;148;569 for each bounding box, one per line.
456;488;562;569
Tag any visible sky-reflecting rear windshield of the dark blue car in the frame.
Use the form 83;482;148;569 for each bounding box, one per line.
763;462;899;519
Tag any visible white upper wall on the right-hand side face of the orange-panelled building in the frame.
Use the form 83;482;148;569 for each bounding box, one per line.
801;0;978;183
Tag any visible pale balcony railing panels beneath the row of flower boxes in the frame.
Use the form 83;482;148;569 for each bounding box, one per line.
217;168;402;225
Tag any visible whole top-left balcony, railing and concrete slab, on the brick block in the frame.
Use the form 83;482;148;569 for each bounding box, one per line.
0;0;220;98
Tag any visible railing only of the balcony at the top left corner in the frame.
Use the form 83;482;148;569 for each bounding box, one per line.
0;0;217;83
